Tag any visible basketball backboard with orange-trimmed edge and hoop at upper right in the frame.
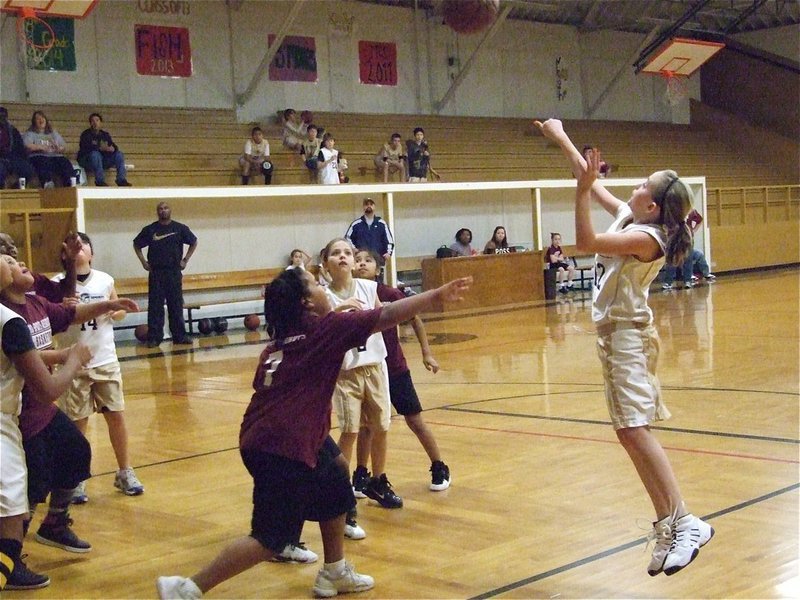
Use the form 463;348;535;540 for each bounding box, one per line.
641;38;725;106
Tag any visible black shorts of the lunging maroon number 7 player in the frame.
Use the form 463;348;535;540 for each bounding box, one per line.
241;436;356;553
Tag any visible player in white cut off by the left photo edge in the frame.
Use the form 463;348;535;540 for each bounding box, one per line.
0;257;91;591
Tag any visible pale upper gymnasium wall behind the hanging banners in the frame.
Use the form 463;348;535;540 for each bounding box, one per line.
0;0;700;123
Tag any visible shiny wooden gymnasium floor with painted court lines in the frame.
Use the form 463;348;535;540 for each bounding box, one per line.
15;269;800;599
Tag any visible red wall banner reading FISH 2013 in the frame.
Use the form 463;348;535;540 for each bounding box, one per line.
134;25;192;77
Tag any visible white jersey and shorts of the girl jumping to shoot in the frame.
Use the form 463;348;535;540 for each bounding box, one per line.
592;204;670;429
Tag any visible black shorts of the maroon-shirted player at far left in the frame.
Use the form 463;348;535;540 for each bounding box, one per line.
22;410;92;504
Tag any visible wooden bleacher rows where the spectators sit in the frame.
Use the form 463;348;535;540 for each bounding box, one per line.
6;103;795;188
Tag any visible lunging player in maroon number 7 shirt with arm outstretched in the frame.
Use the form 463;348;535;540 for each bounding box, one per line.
157;269;470;599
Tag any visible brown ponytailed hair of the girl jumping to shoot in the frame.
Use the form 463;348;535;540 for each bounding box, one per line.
651;170;692;267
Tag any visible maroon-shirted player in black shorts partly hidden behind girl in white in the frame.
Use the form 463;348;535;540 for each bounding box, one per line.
353;250;451;492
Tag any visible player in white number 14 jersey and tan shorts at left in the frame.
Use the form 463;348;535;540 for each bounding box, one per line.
53;233;144;504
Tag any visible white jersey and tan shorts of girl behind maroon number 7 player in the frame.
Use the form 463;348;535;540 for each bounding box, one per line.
325;279;392;433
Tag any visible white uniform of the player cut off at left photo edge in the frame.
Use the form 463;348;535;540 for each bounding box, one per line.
0;304;28;518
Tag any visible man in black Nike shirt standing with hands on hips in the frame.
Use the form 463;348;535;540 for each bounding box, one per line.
133;202;197;348
